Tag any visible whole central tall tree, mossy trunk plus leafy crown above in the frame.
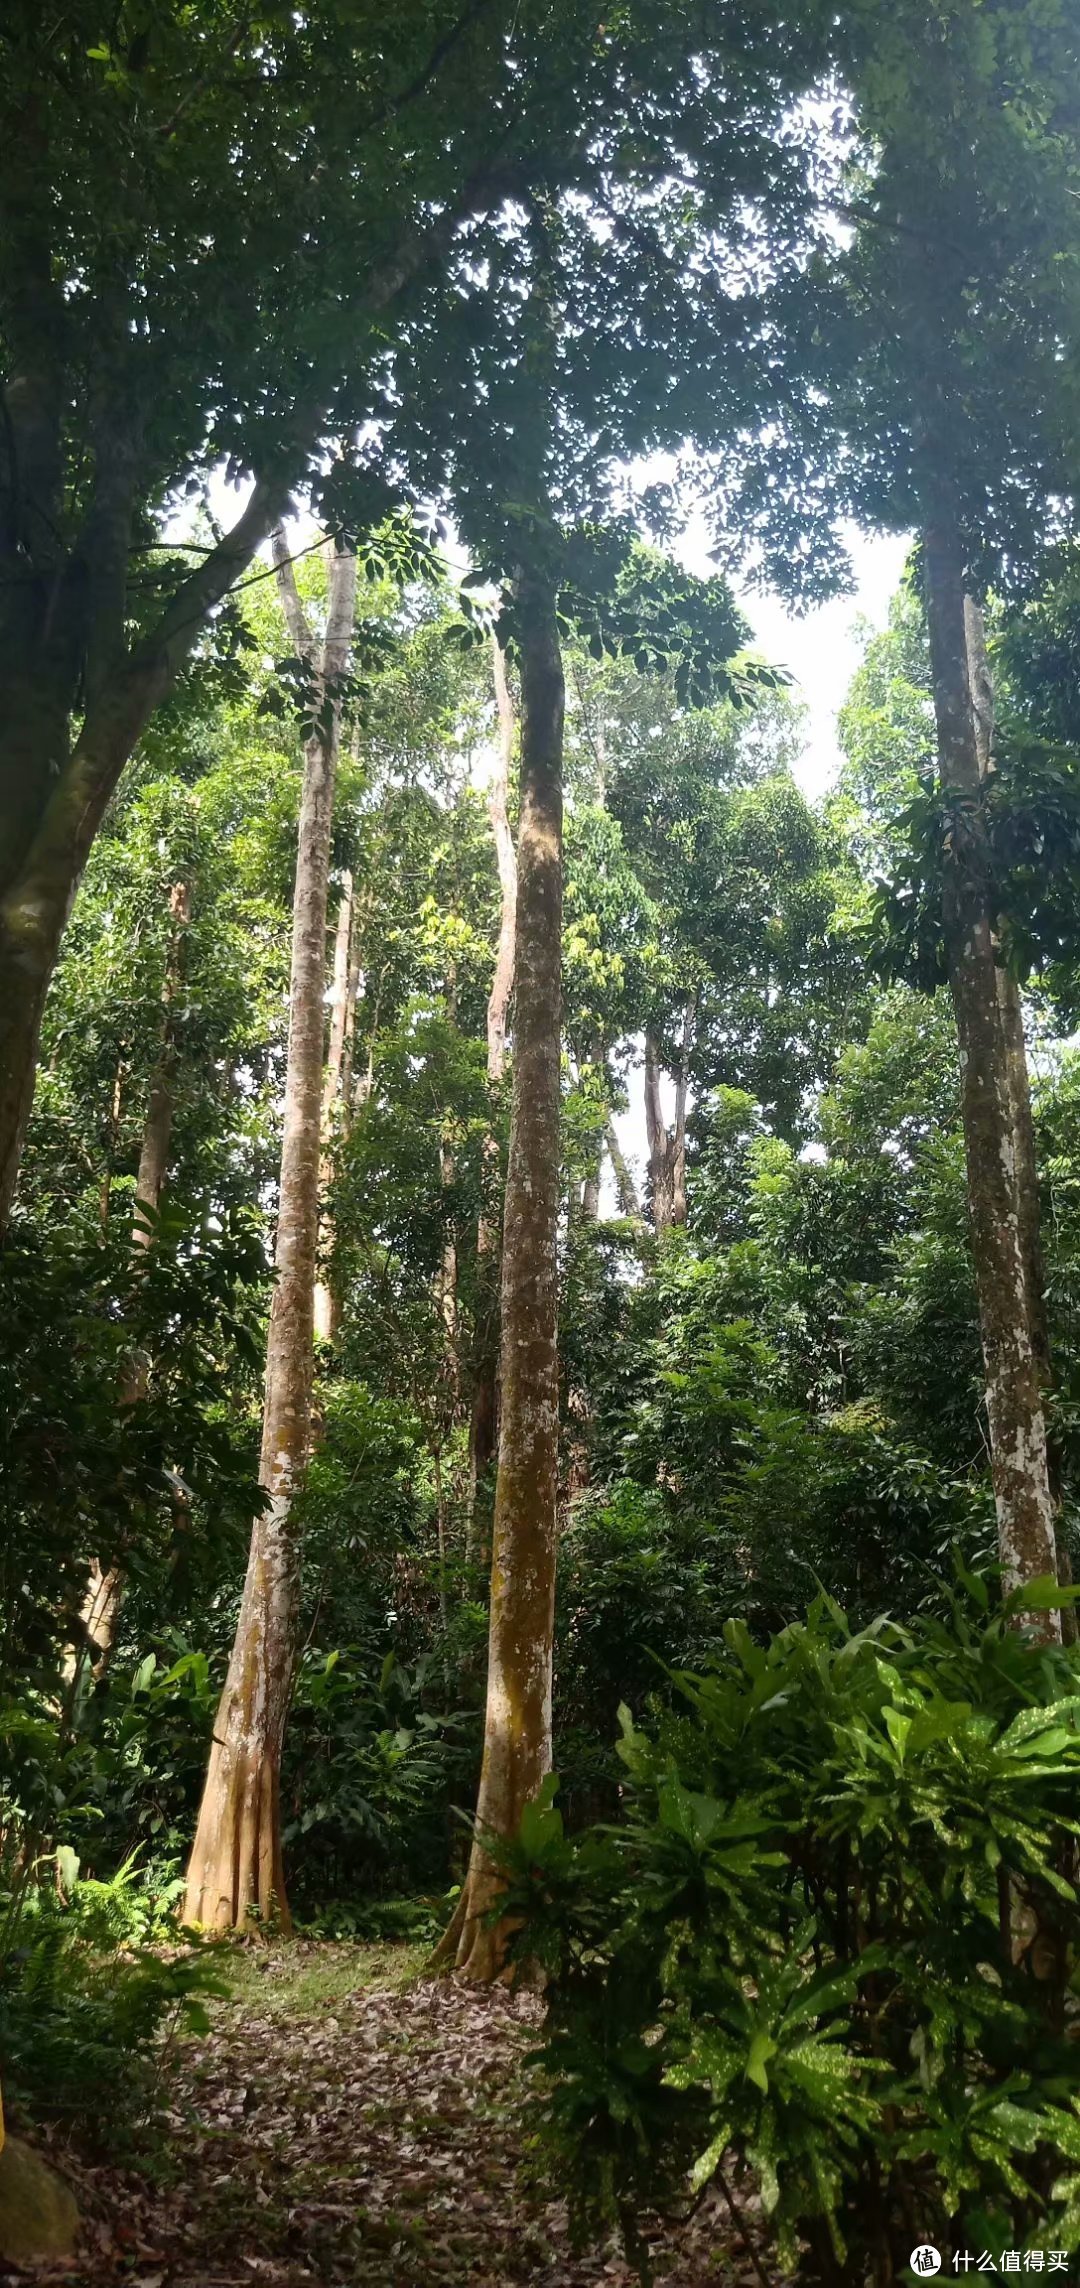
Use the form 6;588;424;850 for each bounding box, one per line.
384;11;851;1975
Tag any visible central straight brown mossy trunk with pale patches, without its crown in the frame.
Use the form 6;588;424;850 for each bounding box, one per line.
439;574;563;1979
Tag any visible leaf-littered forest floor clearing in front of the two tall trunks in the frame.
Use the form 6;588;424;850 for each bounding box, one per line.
27;1943;757;2288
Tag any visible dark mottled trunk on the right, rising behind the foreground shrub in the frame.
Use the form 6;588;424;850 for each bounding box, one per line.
922;501;1062;1638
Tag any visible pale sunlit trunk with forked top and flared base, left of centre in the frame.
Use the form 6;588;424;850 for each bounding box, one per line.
183;531;357;1931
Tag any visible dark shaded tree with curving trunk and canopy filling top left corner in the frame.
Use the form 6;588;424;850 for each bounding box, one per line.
0;0;718;1226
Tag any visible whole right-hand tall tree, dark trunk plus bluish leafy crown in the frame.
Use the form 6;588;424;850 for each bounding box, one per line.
695;0;1080;1636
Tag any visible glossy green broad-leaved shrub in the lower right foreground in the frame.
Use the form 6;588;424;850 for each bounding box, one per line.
506;1579;1080;2281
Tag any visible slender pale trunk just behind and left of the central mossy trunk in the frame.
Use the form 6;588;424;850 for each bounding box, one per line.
464;636;517;1565
